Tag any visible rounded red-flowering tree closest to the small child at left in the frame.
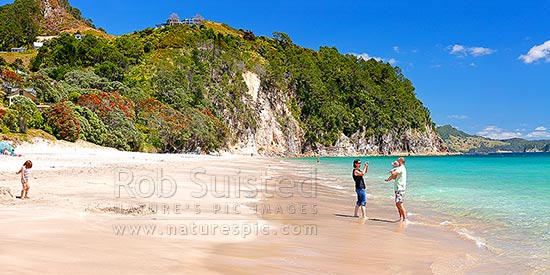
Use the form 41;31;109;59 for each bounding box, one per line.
44;101;80;141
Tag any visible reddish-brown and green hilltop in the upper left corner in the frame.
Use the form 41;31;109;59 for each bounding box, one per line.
0;0;94;50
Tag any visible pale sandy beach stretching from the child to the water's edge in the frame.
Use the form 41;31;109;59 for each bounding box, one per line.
0;141;506;274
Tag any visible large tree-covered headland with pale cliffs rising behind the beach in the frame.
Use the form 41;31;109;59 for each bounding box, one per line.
2;0;447;156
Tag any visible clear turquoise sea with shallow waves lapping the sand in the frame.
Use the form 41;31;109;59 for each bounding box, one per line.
291;153;550;274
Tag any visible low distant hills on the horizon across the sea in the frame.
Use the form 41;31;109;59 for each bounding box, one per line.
436;125;550;154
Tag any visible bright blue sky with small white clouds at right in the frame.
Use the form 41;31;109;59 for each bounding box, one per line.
0;0;550;139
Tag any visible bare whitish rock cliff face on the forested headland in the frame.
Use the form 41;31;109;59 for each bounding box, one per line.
228;72;448;156
